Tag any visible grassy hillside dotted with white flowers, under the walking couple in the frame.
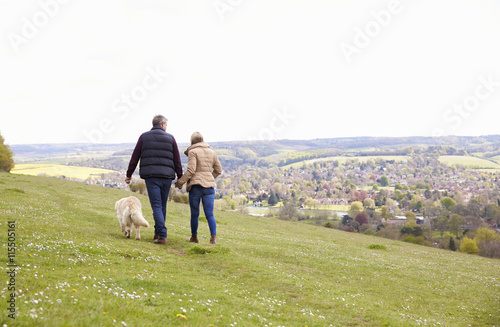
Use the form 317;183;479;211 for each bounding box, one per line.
0;173;500;327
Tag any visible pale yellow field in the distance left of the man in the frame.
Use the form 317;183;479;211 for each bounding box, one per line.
11;164;113;179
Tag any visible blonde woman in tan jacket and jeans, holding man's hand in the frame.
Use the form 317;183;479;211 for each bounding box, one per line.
175;132;222;244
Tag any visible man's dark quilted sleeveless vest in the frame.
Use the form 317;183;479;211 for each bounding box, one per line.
139;126;175;179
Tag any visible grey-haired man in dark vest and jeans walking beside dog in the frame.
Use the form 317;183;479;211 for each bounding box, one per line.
125;115;182;245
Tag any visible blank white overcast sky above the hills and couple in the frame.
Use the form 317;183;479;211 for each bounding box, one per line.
0;0;500;144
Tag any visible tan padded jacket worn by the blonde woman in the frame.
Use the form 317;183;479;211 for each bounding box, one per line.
177;142;222;192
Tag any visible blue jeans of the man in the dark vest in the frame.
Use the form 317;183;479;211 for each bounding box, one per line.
145;178;172;238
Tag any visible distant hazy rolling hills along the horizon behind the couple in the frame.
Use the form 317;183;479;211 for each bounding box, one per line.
11;135;500;170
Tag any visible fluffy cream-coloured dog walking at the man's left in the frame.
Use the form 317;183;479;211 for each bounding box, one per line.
115;196;149;240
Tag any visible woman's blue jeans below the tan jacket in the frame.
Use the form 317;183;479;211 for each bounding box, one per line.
189;185;217;235
